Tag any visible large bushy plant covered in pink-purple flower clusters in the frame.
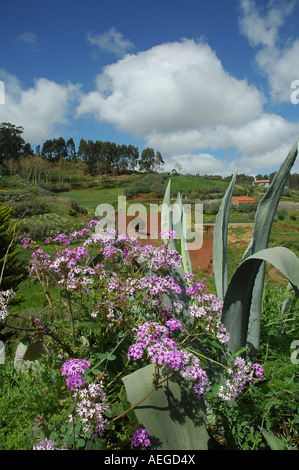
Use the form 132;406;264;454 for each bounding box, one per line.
1;225;262;449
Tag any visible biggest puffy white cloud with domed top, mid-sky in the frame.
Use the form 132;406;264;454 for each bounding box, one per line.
78;40;263;137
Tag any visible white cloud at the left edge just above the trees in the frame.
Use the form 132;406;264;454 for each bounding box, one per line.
0;70;79;144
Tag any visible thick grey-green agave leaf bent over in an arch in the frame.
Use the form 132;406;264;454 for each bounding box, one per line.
222;247;299;356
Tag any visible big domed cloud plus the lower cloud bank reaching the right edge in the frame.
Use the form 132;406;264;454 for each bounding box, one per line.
77;37;298;174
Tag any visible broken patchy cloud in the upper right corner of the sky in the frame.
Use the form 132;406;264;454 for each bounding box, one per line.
239;0;299;102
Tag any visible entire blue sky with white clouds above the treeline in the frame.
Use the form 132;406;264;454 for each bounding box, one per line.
0;0;299;175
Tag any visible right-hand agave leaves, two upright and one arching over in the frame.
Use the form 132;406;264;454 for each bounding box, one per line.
213;137;299;356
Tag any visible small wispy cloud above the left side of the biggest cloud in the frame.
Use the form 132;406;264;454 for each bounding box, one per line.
87;27;135;57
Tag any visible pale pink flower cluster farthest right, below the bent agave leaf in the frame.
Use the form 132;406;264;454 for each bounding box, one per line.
218;356;264;401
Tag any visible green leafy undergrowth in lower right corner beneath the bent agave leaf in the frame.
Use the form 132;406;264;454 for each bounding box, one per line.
211;285;299;450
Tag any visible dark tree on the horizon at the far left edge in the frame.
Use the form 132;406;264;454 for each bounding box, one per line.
0;122;25;164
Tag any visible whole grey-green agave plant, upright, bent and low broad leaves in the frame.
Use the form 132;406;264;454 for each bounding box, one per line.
123;137;299;449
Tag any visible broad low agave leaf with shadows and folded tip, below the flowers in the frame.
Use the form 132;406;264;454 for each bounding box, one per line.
123;364;208;450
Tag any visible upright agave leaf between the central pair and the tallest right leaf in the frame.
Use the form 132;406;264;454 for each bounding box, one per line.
213;170;237;299
